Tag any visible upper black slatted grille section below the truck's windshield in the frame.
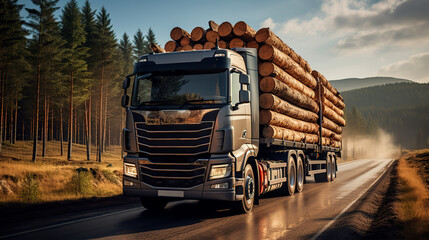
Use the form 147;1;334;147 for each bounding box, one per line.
136;121;214;155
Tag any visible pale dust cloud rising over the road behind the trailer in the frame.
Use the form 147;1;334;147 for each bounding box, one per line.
342;129;401;160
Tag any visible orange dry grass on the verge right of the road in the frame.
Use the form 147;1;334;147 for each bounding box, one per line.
396;149;429;239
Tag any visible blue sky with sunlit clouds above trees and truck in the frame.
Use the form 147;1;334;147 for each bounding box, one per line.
19;0;429;82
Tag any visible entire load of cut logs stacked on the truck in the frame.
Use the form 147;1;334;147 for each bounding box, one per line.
164;21;346;147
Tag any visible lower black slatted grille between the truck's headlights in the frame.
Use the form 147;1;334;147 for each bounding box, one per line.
140;161;207;188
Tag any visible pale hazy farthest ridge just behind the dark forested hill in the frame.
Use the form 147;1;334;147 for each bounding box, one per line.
329;77;413;92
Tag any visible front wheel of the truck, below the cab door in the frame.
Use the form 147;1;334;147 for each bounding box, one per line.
234;164;256;213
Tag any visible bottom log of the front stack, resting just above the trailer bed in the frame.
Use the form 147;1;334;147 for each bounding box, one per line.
262;125;319;143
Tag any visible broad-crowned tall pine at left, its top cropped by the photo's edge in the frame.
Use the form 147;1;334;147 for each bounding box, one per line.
26;0;64;162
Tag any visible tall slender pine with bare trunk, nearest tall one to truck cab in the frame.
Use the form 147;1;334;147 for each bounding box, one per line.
94;7;116;162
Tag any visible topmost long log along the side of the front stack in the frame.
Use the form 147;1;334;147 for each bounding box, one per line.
255;28;311;73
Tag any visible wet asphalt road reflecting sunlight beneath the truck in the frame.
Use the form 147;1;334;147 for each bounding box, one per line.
0;159;393;240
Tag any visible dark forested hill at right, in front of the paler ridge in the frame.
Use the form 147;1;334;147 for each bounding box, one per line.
341;81;429;148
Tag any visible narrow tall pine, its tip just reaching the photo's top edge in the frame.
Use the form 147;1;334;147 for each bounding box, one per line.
61;0;88;161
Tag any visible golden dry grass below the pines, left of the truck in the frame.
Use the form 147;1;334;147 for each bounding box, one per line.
0;141;122;203
